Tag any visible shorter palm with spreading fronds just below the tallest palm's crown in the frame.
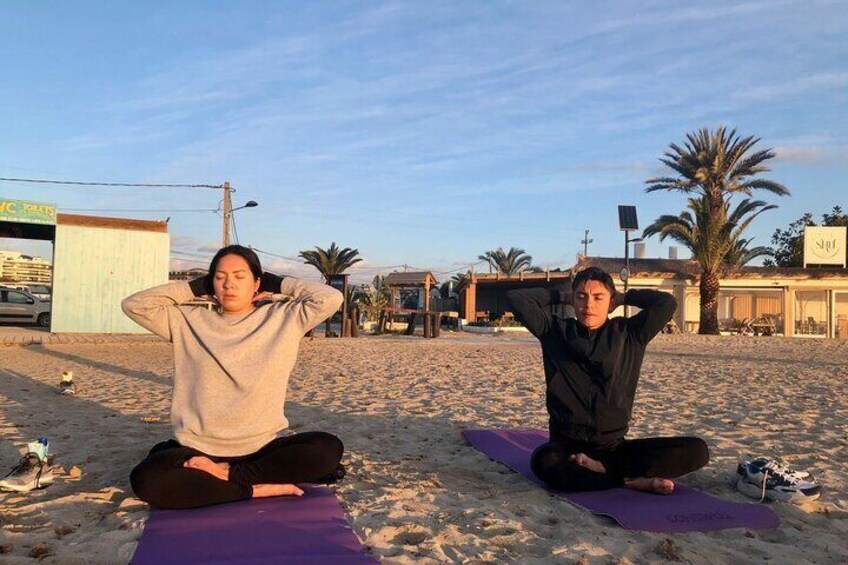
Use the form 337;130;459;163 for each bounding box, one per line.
643;196;777;334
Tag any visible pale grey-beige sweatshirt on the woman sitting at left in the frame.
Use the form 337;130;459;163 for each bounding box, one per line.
121;273;342;457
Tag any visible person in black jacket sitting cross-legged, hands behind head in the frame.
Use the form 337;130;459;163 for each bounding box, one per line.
507;267;709;494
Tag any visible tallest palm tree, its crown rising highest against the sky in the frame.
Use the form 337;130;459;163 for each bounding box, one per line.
645;127;789;334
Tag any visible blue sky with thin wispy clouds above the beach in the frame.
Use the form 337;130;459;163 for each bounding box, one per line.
0;0;848;279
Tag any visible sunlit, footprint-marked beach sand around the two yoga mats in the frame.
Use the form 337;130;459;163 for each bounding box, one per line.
0;334;848;564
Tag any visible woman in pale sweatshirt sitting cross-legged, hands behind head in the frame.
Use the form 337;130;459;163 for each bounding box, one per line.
122;245;344;508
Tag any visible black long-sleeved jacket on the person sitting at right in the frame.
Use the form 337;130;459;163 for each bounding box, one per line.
506;288;677;444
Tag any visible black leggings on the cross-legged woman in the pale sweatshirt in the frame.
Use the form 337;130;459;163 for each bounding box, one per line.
130;432;344;508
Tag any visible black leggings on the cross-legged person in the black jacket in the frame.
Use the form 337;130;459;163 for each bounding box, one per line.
530;437;710;492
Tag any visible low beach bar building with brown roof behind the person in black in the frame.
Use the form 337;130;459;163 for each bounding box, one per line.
458;257;848;339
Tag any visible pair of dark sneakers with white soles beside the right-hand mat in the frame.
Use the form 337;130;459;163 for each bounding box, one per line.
736;457;821;504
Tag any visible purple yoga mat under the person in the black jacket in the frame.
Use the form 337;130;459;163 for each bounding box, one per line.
462;429;780;532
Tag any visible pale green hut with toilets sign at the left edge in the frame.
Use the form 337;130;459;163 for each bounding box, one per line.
0;199;170;333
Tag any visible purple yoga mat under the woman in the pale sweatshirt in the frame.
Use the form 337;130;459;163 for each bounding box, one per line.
132;486;379;565
